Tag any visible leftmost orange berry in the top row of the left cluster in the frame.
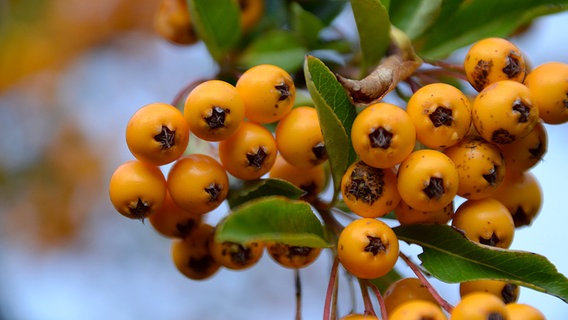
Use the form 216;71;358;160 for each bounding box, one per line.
126;102;189;166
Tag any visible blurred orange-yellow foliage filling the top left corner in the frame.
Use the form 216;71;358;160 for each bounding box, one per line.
0;0;158;92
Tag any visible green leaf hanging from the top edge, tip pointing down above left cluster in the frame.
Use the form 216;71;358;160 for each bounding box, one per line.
187;0;241;62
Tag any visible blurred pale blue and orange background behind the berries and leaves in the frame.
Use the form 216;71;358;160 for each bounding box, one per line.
0;0;568;320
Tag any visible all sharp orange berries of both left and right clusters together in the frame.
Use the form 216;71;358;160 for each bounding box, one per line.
109;34;568;319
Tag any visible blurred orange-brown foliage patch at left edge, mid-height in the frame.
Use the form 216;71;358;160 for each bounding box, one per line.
2;123;105;249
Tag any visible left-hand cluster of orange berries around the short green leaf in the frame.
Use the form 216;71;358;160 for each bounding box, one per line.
109;65;327;279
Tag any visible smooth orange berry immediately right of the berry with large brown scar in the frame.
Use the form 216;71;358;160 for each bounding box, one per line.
397;149;459;211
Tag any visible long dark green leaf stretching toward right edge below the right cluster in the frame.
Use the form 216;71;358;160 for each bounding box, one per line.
393;225;568;302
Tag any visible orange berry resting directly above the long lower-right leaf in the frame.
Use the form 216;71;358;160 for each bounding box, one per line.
452;198;515;248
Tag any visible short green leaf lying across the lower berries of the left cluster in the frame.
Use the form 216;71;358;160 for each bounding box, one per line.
215;196;331;248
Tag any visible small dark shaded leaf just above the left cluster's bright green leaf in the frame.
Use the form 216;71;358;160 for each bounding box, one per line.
228;178;304;208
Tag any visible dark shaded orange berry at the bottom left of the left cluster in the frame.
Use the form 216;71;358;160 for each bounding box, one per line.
171;224;221;280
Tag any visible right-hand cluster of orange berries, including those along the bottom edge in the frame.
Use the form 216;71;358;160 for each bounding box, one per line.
337;38;568;319
